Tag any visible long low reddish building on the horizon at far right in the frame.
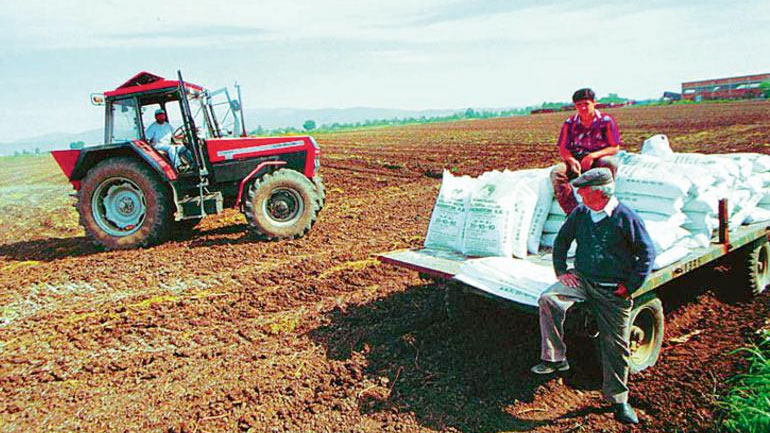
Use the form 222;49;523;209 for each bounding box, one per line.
682;74;770;101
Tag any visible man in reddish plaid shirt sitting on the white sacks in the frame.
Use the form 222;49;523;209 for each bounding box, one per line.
551;89;620;215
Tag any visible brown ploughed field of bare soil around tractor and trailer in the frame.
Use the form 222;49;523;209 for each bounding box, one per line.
0;102;770;432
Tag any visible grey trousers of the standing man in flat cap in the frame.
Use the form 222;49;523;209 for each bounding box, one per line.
539;276;632;403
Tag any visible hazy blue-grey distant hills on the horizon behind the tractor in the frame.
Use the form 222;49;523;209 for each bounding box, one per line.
0;107;516;155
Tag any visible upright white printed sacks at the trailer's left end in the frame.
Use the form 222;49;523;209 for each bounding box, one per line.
425;169;553;258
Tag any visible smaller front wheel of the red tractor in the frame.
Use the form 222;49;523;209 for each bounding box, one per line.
244;169;319;240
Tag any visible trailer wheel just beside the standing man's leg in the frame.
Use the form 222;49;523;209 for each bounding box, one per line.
628;298;664;374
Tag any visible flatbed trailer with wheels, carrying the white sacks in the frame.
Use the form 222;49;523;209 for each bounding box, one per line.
379;218;770;373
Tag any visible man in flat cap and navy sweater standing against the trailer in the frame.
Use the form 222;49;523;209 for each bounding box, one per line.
532;167;655;424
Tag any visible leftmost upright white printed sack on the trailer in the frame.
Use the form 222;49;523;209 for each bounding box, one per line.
425;170;476;252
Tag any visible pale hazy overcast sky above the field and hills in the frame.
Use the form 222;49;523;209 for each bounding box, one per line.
0;0;770;141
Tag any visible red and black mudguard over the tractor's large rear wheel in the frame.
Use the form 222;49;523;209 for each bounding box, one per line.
51;140;177;191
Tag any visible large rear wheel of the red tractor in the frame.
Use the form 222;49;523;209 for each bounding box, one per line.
78;157;171;250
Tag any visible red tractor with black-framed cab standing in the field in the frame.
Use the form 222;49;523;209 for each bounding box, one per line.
52;72;325;250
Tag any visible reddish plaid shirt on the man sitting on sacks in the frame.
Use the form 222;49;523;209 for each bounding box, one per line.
558;110;620;159
